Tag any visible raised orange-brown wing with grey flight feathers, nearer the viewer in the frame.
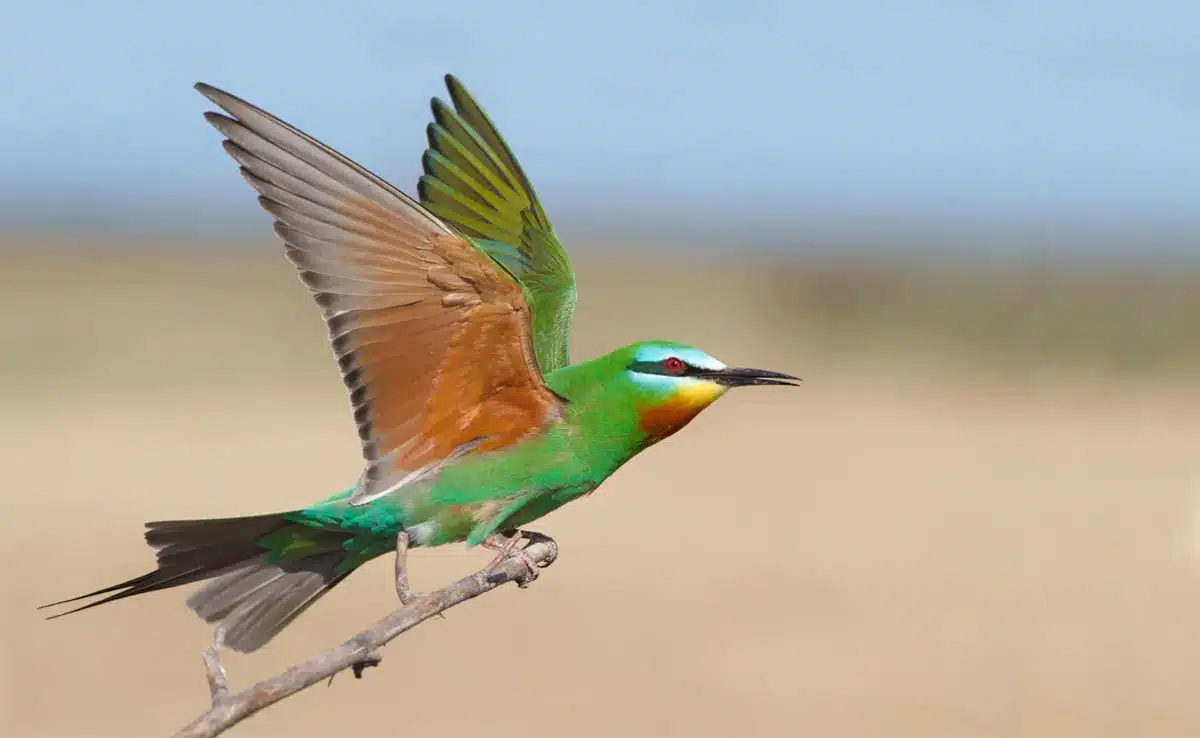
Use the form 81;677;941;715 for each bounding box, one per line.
196;84;563;504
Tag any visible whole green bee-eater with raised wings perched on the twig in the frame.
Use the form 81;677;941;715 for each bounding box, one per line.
43;74;799;653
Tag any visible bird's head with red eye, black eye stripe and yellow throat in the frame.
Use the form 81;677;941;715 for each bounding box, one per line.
623;341;800;443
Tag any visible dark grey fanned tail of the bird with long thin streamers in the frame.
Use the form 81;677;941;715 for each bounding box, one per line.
43;512;367;653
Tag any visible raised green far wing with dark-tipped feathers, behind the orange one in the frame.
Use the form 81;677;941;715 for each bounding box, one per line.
418;74;575;372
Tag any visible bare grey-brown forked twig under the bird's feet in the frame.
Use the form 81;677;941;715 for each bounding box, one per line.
175;536;558;738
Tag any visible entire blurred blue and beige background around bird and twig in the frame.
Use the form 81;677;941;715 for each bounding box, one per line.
7;0;1200;738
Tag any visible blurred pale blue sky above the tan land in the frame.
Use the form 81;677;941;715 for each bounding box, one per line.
0;0;1200;246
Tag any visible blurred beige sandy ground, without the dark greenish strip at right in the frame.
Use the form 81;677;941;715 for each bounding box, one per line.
0;246;1200;738
